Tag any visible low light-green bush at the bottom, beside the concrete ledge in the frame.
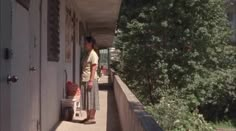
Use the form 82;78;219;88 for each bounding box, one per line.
146;96;214;131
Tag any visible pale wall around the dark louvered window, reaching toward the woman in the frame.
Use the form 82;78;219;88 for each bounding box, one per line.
41;0;83;131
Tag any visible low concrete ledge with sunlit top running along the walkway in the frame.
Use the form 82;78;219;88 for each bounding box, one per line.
110;70;162;131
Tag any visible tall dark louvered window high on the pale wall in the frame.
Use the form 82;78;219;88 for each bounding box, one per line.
47;0;60;62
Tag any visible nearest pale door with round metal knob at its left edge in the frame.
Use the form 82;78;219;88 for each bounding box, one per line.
10;2;32;131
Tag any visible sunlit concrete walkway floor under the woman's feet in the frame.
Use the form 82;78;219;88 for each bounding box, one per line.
56;77;121;131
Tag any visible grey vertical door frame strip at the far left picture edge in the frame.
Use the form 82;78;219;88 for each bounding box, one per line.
0;0;12;131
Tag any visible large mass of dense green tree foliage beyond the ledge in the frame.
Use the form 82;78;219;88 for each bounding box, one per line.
115;0;236;126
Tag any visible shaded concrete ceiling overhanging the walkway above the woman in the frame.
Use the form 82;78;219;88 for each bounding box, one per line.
76;0;121;48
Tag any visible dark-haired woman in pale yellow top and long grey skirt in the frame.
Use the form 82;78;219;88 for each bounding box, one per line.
81;36;99;124
